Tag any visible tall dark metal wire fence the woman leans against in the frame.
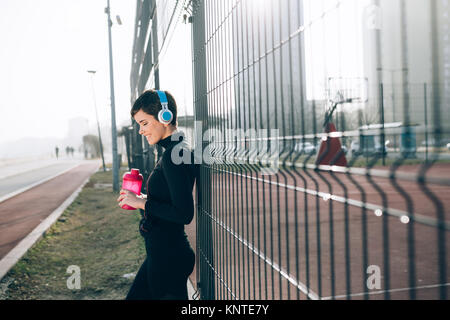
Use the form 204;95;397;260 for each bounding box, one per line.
126;0;450;300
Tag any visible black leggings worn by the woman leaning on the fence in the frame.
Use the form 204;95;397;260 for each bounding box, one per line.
126;236;195;300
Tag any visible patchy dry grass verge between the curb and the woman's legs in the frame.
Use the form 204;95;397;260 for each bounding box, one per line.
0;171;145;300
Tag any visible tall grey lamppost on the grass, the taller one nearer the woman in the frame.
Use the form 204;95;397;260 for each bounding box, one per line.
105;0;119;192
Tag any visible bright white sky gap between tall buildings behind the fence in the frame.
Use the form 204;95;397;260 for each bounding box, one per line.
304;0;368;100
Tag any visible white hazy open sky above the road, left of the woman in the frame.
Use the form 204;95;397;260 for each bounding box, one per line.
0;0;136;143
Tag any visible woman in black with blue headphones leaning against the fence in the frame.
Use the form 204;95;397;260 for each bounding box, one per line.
117;90;197;300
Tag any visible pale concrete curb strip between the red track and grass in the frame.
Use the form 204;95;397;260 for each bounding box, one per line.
0;165;98;280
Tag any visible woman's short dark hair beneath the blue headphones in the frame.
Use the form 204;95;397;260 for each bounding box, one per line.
131;90;177;125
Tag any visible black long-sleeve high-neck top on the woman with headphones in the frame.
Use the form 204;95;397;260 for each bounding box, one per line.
140;132;197;237
